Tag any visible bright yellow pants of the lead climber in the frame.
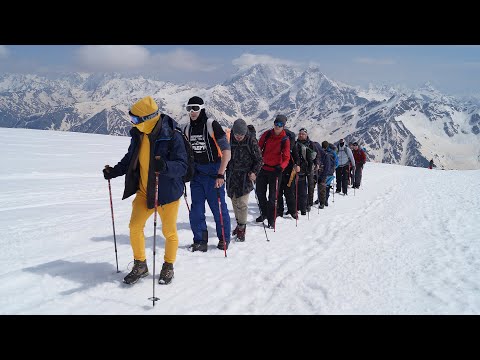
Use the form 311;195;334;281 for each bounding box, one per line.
129;192;180;264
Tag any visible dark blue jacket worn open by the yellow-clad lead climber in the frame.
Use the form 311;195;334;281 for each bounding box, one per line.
113;114;188;209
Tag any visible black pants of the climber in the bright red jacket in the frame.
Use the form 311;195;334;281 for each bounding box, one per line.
257;169;282;225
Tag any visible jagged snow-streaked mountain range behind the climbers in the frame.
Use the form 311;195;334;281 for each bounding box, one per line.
0;64;480;169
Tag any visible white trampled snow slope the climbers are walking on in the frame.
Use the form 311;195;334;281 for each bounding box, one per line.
0;128;480;315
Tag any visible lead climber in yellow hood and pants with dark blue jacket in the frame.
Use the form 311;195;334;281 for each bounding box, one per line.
103;96;188;284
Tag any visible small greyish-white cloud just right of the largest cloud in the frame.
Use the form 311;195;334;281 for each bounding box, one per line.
150;48;218;72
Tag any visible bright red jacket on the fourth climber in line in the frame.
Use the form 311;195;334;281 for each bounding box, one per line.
258;129;290;171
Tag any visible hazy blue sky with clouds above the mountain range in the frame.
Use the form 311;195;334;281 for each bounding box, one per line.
0;45;480;95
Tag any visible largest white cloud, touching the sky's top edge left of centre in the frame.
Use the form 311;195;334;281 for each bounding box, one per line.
77;45;150;71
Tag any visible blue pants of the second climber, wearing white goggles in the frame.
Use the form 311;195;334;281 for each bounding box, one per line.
190;162;231;243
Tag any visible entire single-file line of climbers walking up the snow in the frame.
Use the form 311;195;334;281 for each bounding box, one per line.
103;96;366;284
